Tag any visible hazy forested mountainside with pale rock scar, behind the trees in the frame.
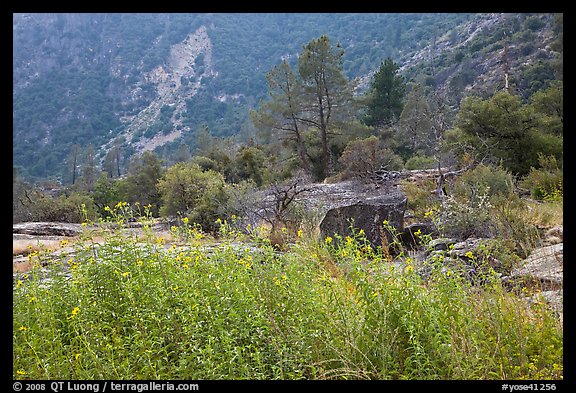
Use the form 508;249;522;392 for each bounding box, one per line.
13;13;558;184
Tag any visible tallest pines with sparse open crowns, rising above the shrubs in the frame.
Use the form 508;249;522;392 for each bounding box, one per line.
251;35;354;180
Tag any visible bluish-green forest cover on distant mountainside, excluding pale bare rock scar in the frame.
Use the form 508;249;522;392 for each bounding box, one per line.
13;13;562;181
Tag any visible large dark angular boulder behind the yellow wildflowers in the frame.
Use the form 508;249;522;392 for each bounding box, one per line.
320;189;407;246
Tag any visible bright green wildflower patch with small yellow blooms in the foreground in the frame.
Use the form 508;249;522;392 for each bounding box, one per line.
13;205;563;380
